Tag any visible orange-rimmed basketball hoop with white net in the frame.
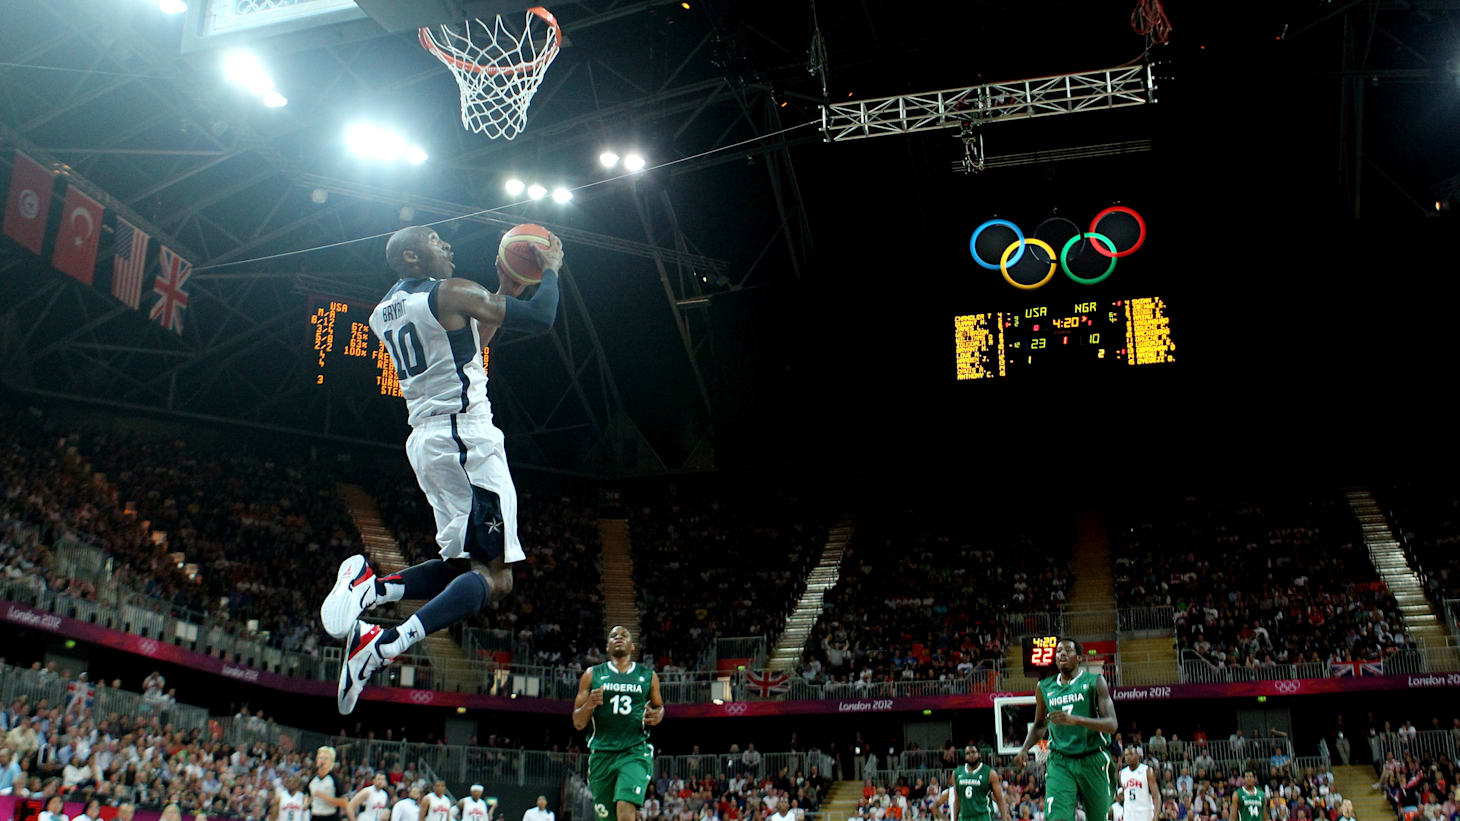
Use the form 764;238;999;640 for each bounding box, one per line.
420;6;562;140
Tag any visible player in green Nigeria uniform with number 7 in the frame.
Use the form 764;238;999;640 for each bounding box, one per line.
1015;638;1117;821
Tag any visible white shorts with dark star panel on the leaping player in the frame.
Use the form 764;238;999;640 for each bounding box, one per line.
406;413;526;564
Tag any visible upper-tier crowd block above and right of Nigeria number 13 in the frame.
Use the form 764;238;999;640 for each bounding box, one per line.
625;479;829;671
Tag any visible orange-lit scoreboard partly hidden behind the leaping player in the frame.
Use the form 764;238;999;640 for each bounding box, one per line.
310;298;491;397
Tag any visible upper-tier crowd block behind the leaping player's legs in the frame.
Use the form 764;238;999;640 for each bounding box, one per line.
374;473;607;668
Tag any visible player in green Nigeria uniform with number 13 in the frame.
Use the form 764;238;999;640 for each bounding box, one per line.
572;625;664;821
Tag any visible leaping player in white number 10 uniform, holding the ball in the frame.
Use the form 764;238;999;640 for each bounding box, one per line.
320;225;562;713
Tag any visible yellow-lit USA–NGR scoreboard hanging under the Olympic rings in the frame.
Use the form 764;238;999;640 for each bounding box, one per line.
953;297;1177;381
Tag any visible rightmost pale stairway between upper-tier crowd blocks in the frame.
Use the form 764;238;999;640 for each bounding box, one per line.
1343;488;1460;672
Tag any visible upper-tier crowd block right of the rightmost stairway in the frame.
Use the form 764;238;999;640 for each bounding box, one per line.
1378;476;1460;605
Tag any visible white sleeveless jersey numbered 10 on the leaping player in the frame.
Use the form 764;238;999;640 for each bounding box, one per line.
369;276;492;425
